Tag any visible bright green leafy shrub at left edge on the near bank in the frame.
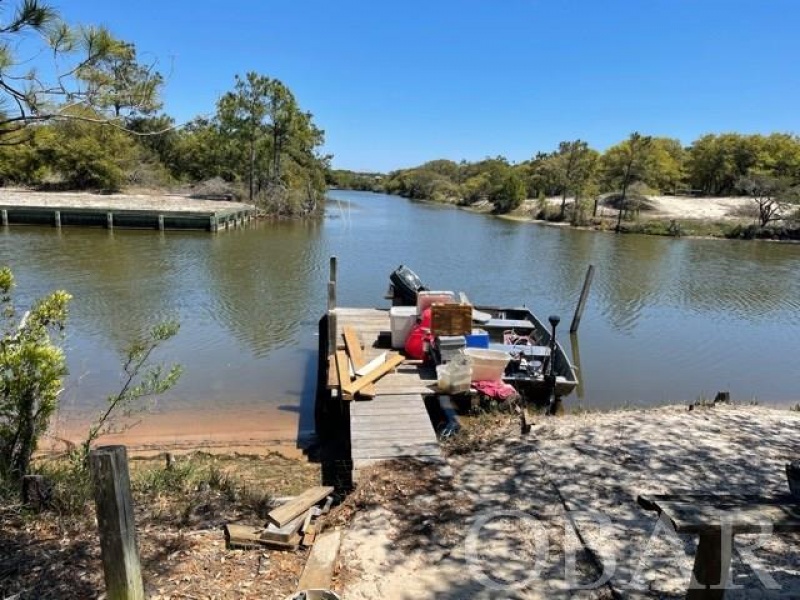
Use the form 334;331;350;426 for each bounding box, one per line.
0;268;71;481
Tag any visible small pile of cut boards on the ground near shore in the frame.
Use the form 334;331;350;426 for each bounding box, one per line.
225;486;333;549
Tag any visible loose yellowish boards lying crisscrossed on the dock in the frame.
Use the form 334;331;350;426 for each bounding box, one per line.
328;326;405;401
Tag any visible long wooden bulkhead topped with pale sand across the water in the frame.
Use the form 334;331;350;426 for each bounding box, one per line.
0;190;256;232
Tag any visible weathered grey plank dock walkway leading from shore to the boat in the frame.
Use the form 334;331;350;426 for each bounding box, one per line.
332;307;444;480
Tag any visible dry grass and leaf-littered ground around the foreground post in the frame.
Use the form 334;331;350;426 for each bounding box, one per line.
0;453;319;600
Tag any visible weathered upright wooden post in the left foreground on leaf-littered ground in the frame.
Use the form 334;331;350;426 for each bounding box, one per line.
89;446;145;600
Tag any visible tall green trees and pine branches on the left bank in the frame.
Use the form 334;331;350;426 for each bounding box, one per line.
0;0;330;215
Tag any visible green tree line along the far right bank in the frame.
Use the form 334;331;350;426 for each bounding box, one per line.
331;132;800;227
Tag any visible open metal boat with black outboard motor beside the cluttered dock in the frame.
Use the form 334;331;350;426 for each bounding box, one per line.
387;265;578;403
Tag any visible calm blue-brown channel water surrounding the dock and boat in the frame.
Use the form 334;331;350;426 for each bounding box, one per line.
0;191;800;440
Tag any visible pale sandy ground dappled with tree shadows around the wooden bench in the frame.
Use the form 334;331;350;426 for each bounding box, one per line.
342;406;800;600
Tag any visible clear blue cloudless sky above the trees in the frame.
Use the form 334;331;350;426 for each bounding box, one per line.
59;0;800;171
